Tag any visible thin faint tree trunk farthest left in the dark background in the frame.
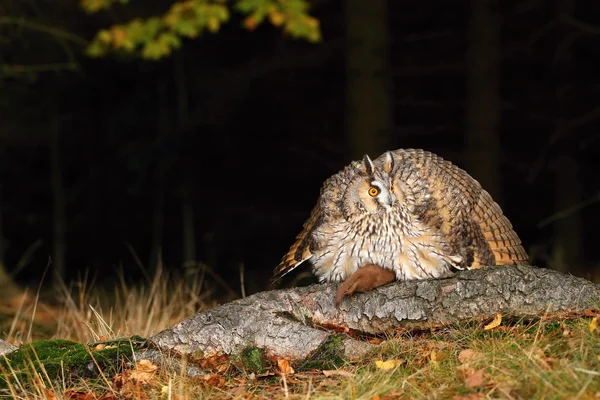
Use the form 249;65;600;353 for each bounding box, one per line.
49;111;67;284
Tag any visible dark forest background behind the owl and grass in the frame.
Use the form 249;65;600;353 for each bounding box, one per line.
0;0;600;294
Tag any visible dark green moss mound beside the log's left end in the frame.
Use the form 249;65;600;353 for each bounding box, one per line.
0;339;137;388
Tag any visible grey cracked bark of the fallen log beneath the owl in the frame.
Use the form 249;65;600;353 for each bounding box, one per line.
150;266;600;360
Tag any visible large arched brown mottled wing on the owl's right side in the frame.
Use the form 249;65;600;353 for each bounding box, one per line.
386;149;528;269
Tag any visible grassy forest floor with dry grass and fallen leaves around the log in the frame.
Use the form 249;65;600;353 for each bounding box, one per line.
0;269;600;400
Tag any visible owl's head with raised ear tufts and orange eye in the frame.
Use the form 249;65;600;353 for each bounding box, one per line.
344;153;396;216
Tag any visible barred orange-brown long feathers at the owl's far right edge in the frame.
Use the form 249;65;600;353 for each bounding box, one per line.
474;190;529;265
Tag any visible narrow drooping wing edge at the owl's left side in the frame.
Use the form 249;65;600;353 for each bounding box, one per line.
271;203;323;286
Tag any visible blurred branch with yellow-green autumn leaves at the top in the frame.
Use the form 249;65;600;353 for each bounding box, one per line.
81;0;321;60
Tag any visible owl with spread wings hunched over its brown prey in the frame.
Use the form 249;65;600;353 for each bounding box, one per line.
272;149;528;306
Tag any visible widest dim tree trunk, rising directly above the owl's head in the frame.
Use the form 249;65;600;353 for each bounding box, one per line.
345;0;392;159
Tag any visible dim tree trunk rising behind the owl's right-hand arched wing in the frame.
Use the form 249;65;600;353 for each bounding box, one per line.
465;0;502;204
